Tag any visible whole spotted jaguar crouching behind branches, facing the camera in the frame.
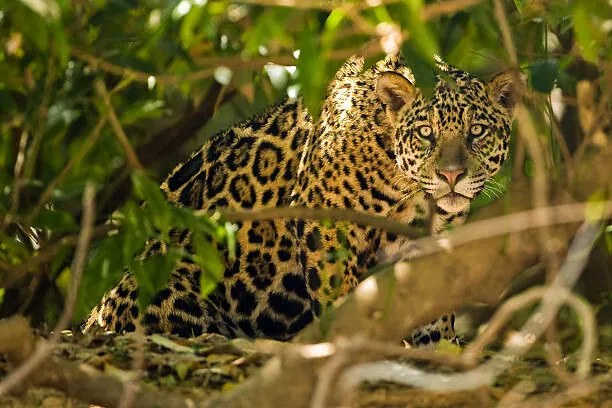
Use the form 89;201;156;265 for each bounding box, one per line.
84;57;511;344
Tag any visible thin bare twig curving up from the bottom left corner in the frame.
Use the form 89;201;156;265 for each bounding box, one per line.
0;182;95;395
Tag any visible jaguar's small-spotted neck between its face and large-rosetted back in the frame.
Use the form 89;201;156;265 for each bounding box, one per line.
296;84;412;215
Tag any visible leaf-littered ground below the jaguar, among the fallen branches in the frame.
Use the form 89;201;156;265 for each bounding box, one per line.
0;332;612;408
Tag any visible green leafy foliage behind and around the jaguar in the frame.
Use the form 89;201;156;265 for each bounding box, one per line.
0;0;612;328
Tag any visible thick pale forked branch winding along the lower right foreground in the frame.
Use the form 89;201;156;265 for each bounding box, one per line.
342;223;599;391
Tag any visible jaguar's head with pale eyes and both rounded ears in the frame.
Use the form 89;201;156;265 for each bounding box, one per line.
377;69;512;213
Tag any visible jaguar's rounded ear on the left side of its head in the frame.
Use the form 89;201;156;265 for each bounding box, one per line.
376;72;418;123
